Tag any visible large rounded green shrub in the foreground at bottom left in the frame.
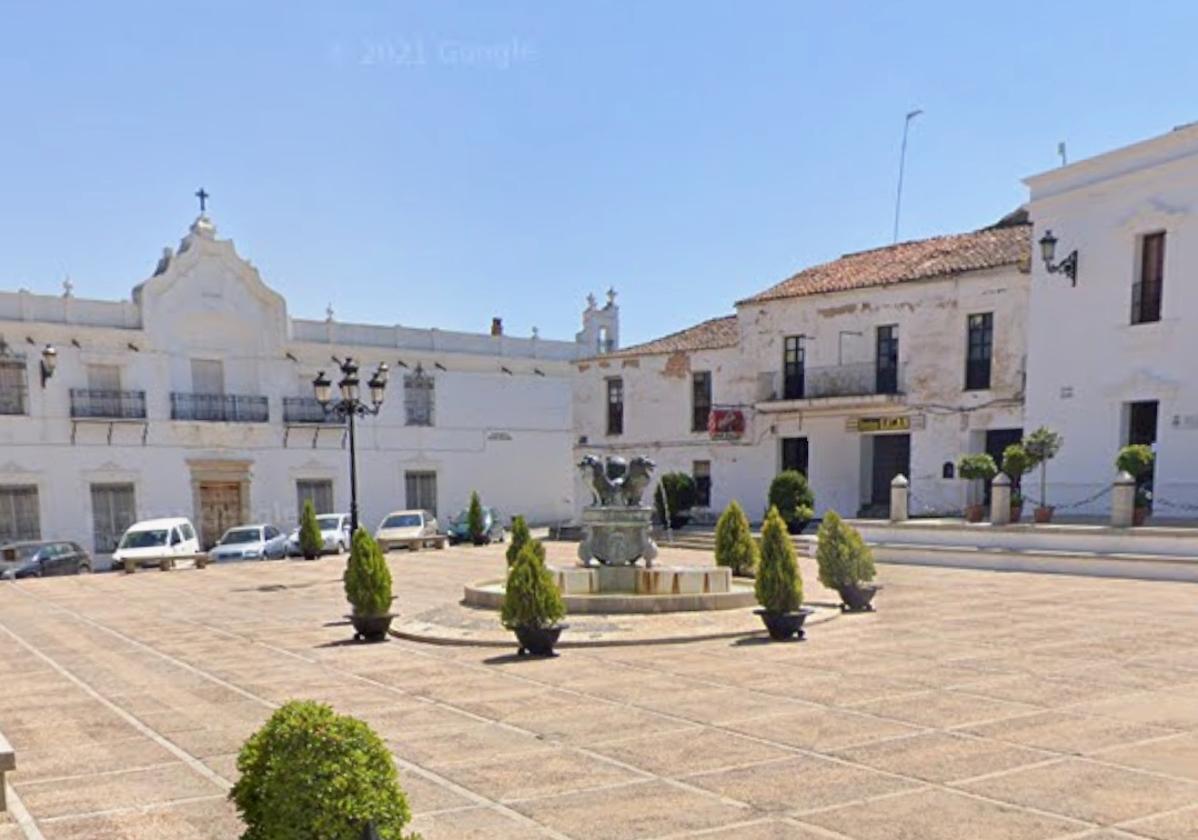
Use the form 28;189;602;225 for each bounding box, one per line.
229;700;412;840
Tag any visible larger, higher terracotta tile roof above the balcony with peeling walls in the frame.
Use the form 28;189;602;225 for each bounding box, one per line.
740;222;1031;303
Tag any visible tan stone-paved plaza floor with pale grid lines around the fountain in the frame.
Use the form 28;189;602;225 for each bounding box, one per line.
0;544;1198;840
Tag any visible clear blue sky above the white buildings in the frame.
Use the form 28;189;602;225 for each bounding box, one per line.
0;0;1198;344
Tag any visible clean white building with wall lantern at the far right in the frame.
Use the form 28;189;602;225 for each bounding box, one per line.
1027;125;1198;518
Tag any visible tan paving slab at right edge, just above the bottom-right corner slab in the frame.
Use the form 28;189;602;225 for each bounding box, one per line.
962;759;1198;826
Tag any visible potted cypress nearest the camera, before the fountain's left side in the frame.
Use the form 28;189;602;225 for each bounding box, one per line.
501;540;565;657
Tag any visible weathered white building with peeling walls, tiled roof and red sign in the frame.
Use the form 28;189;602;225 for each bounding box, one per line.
574;214;1029;519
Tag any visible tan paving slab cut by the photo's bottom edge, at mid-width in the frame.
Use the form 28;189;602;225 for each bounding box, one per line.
514;781;752;840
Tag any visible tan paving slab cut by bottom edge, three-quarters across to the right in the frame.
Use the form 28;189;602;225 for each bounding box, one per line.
803;790;1085;840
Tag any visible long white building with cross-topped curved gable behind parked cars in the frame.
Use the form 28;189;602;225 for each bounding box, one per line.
0;216;618;555
